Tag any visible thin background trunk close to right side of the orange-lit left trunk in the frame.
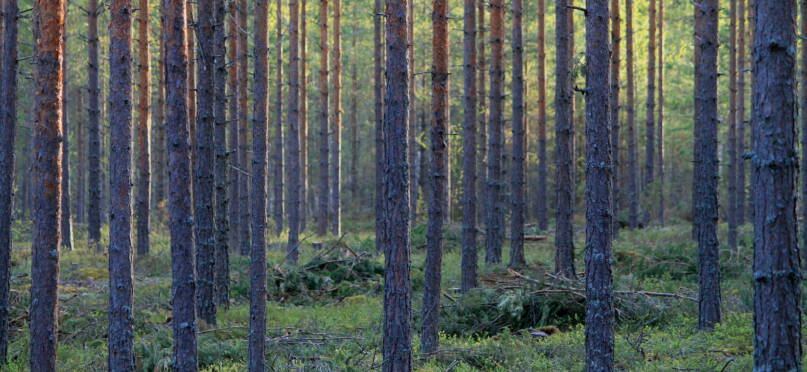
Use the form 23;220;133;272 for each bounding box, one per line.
59;0;73;250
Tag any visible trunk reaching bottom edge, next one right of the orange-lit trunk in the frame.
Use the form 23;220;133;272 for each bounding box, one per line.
108;0;136;371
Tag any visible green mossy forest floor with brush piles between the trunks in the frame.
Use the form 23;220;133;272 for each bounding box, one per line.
4;219;796;372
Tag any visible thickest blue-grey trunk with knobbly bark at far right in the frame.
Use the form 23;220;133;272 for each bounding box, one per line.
752;0;803;371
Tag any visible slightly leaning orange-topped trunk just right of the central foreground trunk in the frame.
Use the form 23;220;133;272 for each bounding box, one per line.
422;0;449;354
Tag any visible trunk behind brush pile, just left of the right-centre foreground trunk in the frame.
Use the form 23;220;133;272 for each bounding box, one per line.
555;0;575;278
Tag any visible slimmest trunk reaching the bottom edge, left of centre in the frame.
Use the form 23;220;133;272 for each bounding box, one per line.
248;0;270;366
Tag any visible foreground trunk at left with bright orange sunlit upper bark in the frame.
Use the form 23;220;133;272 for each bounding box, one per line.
29;0;64;366
